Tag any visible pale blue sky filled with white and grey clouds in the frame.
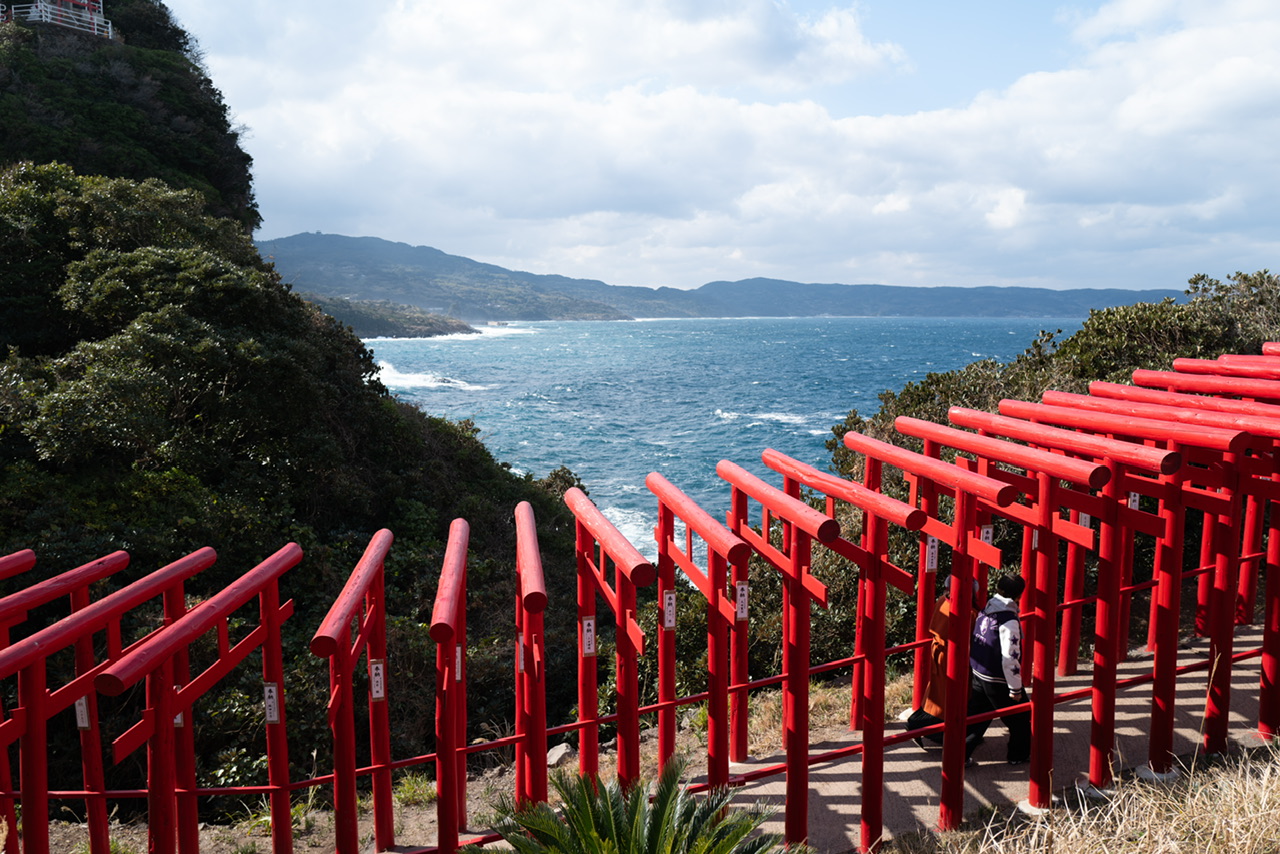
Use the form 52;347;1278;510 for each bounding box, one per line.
160;0;1280;288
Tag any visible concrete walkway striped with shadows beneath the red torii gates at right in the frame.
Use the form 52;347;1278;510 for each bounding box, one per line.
732;626;1261;853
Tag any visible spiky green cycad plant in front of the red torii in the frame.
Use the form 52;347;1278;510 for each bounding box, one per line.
476;762;782;854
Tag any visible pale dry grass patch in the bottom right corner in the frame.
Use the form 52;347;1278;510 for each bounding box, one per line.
887;745;1280;854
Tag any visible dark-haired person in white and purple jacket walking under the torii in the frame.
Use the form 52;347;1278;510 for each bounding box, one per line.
965;575;1032;764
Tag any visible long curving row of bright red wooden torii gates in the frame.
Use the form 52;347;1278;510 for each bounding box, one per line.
0;344;1280;854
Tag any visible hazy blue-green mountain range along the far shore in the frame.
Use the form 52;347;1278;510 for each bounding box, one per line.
259;233;1184;320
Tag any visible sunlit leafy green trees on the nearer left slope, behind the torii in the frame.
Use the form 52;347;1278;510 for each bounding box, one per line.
0;164;586;804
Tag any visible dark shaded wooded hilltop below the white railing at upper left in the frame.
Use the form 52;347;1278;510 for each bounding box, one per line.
0;11;261;230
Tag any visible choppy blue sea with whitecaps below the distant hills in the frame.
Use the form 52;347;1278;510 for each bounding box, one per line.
366;318;1083;556
